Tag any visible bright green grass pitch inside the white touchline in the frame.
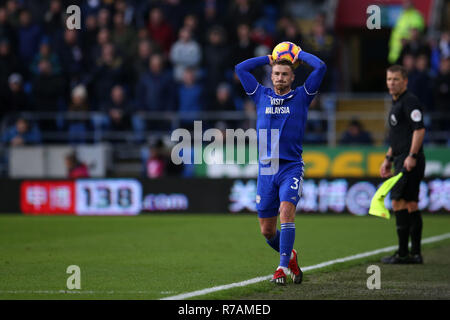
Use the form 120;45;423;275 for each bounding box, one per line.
0;214;450;299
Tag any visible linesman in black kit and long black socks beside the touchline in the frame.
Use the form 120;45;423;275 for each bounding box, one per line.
380;65;425;264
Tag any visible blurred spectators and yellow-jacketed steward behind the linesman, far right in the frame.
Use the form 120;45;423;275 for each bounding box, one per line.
388;0;450;143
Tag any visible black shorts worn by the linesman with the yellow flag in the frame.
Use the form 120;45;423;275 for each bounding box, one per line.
391;153;425;202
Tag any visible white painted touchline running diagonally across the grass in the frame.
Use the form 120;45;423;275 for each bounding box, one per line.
160;233;450;300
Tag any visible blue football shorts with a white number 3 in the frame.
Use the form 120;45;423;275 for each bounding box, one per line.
256;160;304;218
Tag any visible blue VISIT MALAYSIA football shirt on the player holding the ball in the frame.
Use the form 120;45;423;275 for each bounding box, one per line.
235;51;327;164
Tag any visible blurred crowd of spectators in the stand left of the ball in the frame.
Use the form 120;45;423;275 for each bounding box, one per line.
0;0;334;143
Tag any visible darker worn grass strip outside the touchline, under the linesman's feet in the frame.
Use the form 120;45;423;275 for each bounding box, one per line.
236;244;450;300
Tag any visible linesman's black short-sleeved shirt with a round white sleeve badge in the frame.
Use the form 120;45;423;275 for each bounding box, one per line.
389;90;424;156
